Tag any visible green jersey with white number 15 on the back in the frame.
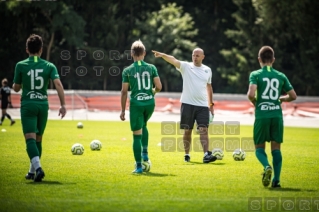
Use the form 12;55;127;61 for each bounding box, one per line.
13;56;59;104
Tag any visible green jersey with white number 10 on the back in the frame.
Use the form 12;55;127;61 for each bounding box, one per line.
122;61;158;106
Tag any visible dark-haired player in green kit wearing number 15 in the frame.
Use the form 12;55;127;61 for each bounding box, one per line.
13;34;66;182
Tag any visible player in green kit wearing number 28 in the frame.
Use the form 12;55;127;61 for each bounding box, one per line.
247;46;297;188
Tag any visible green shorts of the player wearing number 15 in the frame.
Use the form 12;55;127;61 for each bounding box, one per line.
20;103;49;135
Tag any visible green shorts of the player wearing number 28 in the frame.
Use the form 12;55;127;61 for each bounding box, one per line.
254;117;284;145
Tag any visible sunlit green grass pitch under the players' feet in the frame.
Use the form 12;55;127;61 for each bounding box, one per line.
0;120;319;212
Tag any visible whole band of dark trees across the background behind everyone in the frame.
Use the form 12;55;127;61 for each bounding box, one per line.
0;0;319;96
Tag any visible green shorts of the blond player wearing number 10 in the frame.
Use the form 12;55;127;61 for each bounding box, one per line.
130;105;155;131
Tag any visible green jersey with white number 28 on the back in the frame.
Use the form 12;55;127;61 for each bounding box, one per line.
249;66;293;119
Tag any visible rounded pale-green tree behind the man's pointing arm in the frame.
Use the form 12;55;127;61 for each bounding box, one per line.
136;3;197;91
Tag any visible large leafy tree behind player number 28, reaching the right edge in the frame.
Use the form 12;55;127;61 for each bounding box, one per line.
218;0;319;95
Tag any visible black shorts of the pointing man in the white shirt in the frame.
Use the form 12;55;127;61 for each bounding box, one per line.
180;103;209;129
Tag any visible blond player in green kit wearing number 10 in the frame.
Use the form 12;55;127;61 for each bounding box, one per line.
120;40;162;174
